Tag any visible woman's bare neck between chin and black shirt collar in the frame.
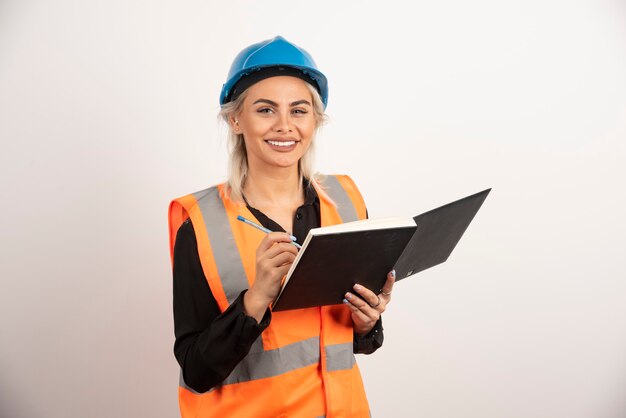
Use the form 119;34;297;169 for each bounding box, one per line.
243;166;304;208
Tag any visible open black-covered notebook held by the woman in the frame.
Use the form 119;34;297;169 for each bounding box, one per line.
272;189;491;311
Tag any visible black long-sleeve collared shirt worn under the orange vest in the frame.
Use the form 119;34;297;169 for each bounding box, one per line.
174;182;383;392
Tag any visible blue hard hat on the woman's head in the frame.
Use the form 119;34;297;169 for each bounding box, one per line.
220;36;328;109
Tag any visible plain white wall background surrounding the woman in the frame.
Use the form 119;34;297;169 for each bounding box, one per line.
0;0;626;418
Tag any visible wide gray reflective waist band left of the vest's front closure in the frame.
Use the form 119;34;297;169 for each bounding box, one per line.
222;337;320;385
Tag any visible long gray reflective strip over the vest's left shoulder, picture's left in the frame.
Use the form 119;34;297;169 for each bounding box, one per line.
193;187;249;304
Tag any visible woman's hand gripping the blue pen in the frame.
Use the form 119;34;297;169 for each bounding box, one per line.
243;232;298;322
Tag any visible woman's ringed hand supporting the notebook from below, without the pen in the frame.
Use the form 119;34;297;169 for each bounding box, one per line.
343;270;396;336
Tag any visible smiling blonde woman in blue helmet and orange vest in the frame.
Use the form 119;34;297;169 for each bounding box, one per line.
169;37;395;417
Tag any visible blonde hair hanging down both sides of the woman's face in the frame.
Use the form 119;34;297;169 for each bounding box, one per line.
218;82;327;203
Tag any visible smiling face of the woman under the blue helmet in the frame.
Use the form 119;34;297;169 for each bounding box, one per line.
231;76;316;170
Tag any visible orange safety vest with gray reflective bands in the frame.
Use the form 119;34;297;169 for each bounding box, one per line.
169;176;370;418
